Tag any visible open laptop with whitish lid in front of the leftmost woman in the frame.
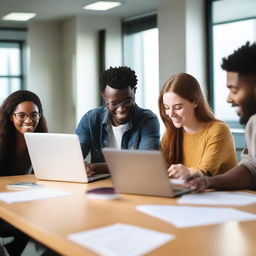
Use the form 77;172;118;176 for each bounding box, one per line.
24;133;110;183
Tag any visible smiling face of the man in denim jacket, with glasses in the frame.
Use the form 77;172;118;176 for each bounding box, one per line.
103;85;135;126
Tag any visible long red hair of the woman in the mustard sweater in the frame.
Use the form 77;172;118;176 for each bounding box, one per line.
158;73;217;165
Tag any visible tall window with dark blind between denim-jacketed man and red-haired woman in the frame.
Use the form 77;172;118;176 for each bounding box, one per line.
123;15;159;121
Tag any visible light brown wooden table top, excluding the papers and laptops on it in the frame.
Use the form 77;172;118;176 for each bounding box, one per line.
0;175;256;256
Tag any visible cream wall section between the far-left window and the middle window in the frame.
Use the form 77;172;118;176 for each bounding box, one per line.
27;16;122;133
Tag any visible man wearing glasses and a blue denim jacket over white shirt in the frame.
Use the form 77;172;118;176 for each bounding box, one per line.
76;67;160;175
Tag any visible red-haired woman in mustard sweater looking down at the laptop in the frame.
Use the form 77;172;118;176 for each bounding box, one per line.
158;73;237;179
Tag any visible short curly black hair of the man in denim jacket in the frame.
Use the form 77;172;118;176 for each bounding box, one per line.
101;67;138;92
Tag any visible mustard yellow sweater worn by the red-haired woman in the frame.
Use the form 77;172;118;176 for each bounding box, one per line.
182;121;237;175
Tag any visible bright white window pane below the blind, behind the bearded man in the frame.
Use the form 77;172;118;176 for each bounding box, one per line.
213;19;256;123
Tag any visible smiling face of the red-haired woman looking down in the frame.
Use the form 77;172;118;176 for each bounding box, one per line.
163;92;198;130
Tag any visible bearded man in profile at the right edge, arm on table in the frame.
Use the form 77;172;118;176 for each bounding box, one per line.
187;42;256;191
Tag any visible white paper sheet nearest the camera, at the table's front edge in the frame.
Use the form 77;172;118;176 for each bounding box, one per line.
68;223;174;256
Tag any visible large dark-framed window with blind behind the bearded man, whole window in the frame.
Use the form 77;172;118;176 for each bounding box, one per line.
208;0;256;159
